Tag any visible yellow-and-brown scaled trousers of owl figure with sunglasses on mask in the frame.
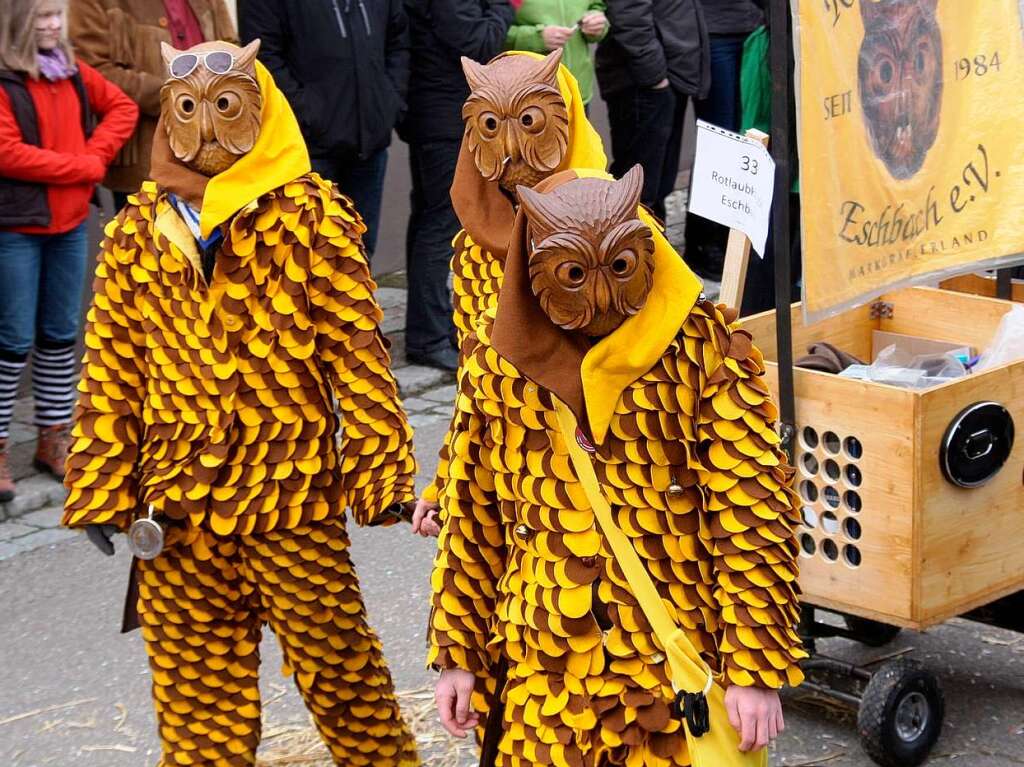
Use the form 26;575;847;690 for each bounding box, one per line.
137;521;419;767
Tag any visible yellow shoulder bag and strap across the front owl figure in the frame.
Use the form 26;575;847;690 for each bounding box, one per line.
555;399;768;767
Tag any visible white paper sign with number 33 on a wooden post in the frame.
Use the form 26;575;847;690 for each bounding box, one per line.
689;120;775;258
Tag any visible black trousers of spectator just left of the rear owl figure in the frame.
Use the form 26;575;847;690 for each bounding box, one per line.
406;140;460;354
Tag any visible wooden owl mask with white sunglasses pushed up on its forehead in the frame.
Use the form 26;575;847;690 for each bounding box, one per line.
160;40;263;176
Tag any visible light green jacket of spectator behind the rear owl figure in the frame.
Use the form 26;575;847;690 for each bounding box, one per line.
505;0;608;103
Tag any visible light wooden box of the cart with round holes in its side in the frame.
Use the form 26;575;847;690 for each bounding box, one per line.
743;288;1024;628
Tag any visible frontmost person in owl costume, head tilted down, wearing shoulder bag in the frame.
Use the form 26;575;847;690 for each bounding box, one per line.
428;167;805;767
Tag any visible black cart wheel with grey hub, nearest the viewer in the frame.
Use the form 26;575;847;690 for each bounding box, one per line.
857;657;945;767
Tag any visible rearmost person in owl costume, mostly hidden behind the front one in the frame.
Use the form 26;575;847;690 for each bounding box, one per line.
413;48;607;536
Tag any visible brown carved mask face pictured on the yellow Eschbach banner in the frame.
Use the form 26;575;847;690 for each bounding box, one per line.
858;0;942;179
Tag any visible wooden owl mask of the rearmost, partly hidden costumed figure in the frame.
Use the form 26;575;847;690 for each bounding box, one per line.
462;49;569;194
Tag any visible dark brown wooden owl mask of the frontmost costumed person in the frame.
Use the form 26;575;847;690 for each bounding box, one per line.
518;165;654;336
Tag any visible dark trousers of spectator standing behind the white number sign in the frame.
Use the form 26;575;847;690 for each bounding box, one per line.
686;35;746;257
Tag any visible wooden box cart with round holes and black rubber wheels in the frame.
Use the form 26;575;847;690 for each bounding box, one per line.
742;288;1024;767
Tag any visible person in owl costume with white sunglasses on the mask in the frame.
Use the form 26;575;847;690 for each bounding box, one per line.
63;41;419;767
